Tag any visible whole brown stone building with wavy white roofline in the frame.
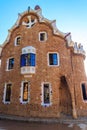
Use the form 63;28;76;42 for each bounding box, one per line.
0;6;87;118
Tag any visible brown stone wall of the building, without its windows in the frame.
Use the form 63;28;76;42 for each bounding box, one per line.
0;10;86;117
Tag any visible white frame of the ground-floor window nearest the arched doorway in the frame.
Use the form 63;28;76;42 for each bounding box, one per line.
41;82;52;107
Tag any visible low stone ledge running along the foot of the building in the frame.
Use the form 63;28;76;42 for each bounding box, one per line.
0;114;87;124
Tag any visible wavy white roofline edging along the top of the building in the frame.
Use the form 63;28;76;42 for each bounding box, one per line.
2;8;85;55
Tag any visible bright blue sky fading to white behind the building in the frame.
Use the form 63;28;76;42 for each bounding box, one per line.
0;0;87;74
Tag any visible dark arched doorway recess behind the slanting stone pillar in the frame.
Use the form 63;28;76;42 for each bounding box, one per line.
59;76;72;115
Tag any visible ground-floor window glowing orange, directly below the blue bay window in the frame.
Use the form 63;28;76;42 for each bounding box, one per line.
20;81;29;104
